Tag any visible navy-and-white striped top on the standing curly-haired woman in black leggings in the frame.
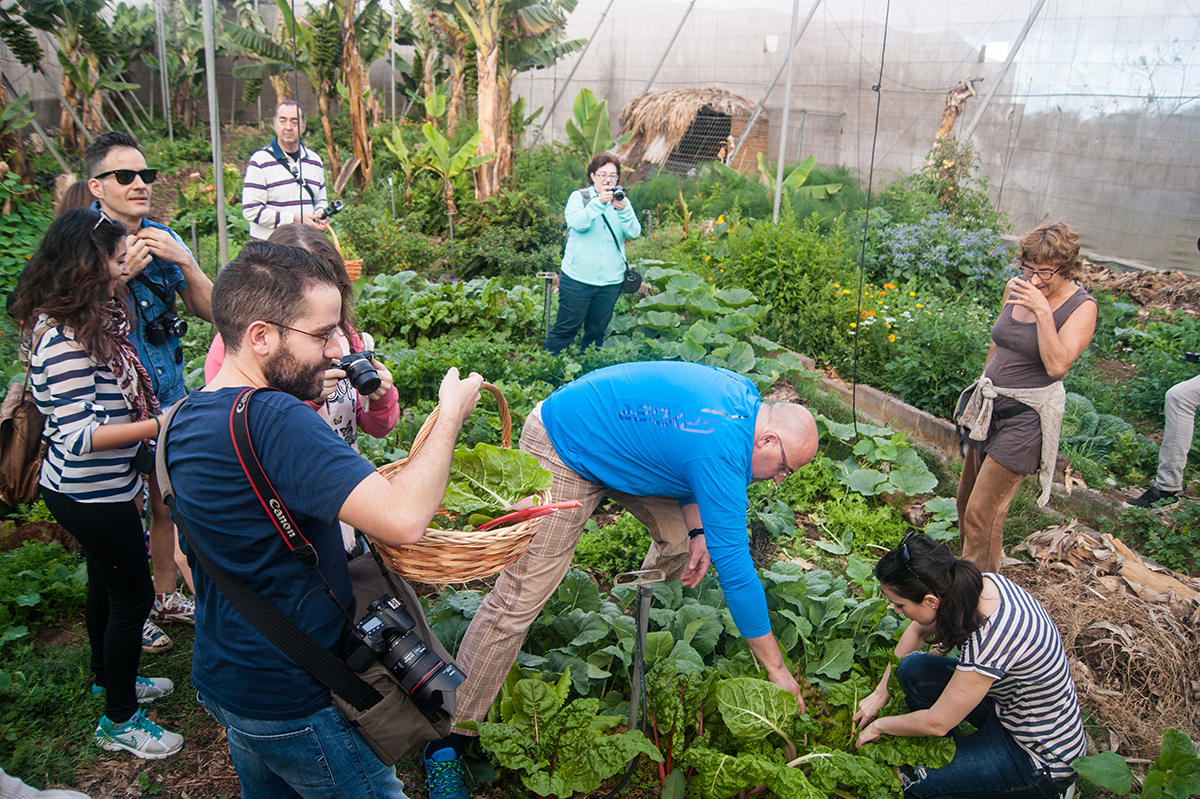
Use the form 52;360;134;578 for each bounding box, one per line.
29;317;142;503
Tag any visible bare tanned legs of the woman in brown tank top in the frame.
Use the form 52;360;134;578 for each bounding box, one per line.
958;446;1025;572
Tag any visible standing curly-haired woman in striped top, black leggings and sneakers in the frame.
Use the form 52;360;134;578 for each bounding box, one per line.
11;209;184;759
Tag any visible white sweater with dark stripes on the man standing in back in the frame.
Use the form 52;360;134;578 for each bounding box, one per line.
241;139;326;239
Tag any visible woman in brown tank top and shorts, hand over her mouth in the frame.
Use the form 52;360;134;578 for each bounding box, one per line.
958;222;1097;572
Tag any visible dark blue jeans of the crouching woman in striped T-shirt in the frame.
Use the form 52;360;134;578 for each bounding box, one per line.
896;653;1070;799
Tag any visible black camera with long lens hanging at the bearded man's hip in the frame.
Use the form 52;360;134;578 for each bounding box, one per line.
342;596;467;723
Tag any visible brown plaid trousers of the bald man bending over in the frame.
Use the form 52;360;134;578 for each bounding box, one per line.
454;411;688;734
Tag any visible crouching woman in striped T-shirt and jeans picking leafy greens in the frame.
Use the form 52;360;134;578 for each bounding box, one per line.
853;535;1087;799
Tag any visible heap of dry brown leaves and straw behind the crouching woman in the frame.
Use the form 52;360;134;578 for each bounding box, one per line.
1012;521;1200;758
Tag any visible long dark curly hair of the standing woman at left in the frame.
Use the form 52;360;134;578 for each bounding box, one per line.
10;209;125;361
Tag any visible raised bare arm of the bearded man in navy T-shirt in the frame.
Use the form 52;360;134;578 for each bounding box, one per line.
337;368;484;546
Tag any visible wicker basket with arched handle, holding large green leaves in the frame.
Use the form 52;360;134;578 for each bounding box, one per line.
374;383;550;585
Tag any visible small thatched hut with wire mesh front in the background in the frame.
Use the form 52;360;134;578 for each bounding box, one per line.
617;88;766;177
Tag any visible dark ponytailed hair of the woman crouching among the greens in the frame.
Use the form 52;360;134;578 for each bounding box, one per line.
875;533;983;649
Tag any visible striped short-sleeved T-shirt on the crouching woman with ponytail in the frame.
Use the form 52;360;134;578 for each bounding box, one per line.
958;573;1087;780
